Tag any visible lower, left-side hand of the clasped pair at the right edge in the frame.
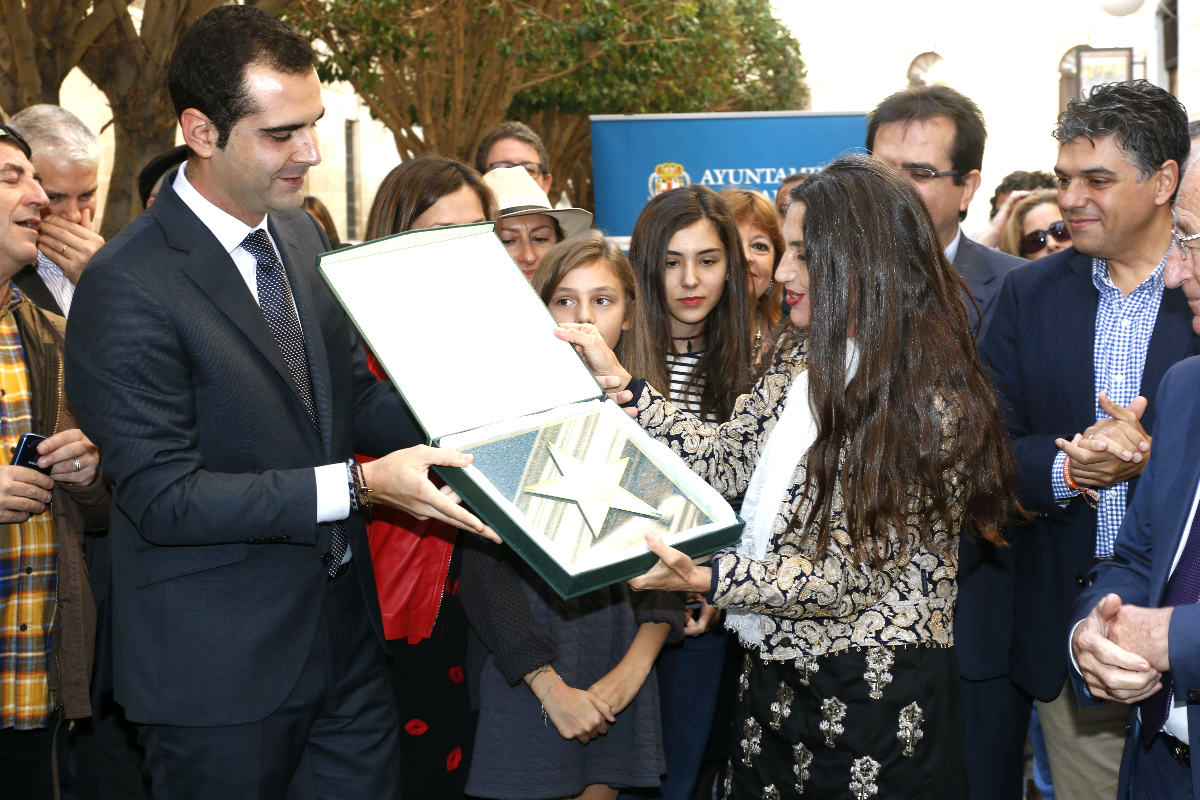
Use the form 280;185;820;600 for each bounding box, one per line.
1070;595;1162;704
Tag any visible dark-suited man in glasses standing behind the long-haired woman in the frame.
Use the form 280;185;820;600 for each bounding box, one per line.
866;86;1026;800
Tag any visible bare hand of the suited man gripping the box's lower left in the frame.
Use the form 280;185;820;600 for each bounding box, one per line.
362;445;500;543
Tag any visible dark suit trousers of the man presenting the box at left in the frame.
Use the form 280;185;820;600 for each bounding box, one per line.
140;561;400;800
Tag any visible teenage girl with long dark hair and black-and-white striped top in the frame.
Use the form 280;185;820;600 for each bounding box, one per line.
629;186;750;800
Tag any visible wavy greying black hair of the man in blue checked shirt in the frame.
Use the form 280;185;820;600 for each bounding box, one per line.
1054;79;1192;190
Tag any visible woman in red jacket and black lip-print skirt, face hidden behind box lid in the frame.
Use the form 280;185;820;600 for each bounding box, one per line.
360;156;496;799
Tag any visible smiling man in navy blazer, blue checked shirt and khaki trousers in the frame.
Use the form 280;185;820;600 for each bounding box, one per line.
979;82;1200;800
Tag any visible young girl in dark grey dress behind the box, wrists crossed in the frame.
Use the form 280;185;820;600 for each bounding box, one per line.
462;230;683;800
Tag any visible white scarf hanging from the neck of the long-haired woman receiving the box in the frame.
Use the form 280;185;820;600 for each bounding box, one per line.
713;339;858;648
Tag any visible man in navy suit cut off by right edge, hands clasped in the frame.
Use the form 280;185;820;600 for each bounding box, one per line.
1072;152;1200;800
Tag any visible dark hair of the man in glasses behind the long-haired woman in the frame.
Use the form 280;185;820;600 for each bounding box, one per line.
866;86;988;185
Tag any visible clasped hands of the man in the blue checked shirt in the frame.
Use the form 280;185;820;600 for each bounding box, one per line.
1055;392;1151;488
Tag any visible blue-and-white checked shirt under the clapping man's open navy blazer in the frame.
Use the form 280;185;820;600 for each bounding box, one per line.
1050;251;1170;558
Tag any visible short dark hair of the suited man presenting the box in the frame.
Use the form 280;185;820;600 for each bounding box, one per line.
167;6;317;149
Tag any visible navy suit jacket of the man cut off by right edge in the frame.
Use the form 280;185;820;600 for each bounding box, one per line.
1072;359;1200;800
